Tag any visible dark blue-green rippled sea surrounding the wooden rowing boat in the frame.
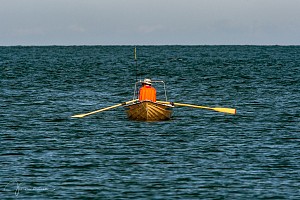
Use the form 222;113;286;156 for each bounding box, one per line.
0;46;300;199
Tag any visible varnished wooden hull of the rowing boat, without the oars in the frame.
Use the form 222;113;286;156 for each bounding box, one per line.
125;101;173;121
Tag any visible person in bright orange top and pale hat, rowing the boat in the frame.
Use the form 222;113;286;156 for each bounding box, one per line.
139;79;156;102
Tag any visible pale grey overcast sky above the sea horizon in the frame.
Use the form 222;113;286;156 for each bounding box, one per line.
0;0;300;45
